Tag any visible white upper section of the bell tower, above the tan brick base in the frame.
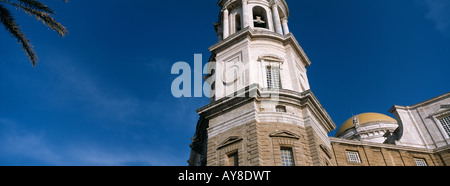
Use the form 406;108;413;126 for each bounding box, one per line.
208;0;311;100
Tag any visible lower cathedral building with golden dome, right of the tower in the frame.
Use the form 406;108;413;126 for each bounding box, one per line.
330;93;450;166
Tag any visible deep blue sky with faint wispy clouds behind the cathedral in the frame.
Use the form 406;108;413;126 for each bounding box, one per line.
0;0;450;165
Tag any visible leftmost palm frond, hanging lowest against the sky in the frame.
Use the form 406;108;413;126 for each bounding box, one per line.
0;4;38;66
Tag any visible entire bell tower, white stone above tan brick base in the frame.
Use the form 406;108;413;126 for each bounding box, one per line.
188;0;336;166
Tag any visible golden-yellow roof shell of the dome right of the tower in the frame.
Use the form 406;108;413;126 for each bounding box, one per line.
336;113;397;136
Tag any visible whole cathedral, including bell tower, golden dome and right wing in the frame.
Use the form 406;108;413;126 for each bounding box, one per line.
188;0;450;166
